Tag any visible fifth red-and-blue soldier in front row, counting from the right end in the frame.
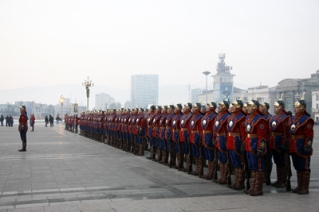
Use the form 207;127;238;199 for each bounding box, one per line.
189;103;204;178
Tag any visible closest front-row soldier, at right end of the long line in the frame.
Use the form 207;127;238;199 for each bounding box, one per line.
244;100;267;196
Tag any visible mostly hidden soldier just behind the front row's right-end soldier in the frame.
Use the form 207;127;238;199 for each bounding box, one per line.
259;102;272;185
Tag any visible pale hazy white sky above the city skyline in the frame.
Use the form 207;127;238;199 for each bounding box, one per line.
0;0;319;91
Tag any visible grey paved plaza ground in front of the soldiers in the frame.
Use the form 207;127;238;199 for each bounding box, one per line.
0;123;319;212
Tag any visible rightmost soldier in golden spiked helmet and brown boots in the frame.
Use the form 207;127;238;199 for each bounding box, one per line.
289;94;314;194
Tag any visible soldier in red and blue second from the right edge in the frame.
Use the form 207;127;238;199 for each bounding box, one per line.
269;99;289;188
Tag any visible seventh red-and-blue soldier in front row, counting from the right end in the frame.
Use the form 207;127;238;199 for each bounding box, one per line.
172;104;184;170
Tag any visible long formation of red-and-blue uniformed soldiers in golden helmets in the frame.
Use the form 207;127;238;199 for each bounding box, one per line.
66;95;314;196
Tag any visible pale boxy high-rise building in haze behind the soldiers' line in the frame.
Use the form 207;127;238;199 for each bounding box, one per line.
131;74;158;108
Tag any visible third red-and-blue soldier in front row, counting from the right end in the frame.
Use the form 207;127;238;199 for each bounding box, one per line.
214;101;230;184
